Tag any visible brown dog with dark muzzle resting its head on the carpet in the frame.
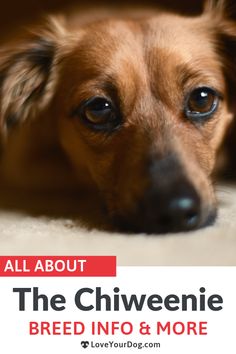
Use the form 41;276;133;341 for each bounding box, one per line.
0;0;236;234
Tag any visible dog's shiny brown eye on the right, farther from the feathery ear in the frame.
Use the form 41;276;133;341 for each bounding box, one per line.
185;87;220;121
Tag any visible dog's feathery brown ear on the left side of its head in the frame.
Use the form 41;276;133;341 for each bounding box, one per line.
0;18;66;131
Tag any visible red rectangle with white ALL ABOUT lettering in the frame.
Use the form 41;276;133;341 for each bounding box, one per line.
0;256;116;277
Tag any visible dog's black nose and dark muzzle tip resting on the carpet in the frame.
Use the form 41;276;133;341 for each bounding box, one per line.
113;181;202;234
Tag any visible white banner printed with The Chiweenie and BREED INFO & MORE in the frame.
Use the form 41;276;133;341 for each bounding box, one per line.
0;267;233;354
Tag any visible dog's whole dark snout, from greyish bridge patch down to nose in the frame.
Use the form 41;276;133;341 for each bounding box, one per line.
111;155;216;234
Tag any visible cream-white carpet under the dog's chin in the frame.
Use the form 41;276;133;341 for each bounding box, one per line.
0;186;236;266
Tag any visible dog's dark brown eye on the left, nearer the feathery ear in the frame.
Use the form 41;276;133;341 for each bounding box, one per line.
77;97;120;130
